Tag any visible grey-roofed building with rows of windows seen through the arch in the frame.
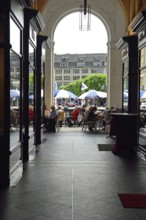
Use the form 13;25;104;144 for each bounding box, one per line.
54;53;107;88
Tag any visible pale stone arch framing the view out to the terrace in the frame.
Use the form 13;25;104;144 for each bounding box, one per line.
44;3;126;110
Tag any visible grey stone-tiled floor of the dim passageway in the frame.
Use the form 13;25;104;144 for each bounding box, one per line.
0;127;146;220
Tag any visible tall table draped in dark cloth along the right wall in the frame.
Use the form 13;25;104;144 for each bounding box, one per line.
110;113;138;156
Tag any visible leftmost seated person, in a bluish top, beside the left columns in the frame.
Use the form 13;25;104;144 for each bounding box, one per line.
45;106;58;132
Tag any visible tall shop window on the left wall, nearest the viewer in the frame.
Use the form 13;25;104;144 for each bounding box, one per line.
10;18;22;179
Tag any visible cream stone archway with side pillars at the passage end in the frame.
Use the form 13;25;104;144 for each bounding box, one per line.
43;0;126;107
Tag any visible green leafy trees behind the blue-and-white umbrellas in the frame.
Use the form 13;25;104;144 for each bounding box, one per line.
60;73;107;96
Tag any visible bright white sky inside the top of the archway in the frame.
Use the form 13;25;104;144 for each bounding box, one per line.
54;12;108;54
